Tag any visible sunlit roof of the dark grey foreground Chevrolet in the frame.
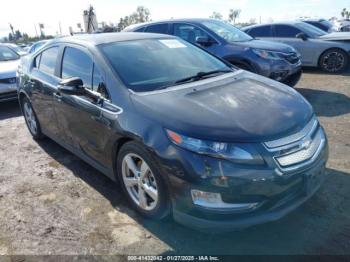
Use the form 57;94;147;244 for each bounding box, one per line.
51;32;172;45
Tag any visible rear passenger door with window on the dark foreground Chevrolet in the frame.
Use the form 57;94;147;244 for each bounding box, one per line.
27;46;60;137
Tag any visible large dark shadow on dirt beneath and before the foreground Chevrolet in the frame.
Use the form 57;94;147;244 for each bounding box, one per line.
39;139;350;255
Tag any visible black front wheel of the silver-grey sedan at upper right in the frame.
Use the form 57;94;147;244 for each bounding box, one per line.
319;48;349;73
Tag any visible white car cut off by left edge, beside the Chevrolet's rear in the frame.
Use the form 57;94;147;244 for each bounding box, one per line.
0;44;20;102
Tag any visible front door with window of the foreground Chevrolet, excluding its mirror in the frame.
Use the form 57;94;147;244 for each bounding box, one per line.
53;45;119;167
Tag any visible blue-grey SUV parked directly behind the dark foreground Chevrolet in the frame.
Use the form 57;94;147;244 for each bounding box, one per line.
125;19;301;86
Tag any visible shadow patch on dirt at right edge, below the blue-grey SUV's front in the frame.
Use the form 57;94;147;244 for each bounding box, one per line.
296;88;350;117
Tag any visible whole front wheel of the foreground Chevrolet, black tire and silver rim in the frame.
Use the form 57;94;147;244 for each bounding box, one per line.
117;141;171;220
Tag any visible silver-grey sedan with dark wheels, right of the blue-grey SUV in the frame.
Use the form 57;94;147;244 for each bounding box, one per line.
243;21;350;73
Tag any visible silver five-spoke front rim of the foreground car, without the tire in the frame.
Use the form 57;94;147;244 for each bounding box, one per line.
122;153;158;211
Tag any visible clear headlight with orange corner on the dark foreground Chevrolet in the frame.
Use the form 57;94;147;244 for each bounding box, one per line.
166;130;264;165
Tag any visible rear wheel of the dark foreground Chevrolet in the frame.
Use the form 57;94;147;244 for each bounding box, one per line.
21;97;44;140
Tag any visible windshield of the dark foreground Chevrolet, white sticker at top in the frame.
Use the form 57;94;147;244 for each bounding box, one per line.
101;38;231;92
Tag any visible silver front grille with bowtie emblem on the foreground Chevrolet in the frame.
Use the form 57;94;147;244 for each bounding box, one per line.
264;118;326;171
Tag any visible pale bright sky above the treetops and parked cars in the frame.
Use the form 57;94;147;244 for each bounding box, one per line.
0;0;350;37
